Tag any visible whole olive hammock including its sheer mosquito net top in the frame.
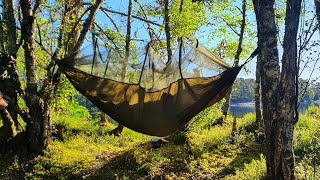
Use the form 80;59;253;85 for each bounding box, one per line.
57;39;241;136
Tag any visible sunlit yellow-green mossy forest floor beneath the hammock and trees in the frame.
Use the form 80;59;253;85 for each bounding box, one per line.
0;105;320;179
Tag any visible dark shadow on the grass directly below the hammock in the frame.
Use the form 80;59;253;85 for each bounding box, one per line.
86;143;188;179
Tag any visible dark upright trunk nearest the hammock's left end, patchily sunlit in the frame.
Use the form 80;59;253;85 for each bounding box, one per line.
20;0;50;154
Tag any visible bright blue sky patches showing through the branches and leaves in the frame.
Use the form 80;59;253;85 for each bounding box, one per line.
90;0;320;79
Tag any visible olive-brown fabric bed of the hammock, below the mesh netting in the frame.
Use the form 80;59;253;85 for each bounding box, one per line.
57;60;241;136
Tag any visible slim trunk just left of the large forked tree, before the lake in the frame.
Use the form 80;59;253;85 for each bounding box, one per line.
254;55;264;132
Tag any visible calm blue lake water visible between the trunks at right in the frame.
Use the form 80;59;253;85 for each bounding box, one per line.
230;103;312;118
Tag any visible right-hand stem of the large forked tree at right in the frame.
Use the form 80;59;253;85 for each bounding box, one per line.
280;0;302;179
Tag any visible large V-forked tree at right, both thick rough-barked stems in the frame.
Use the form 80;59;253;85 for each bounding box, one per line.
253;0;301;179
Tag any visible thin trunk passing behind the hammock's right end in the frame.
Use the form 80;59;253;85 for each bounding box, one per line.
218;0;247;124
